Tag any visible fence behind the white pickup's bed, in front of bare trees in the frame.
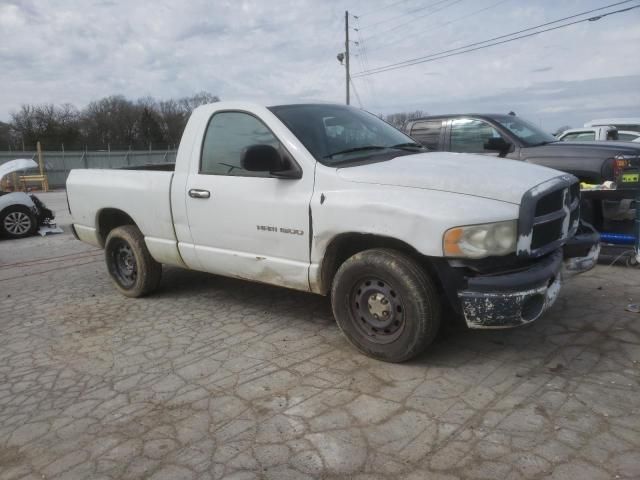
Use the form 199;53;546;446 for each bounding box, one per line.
0;150;177;189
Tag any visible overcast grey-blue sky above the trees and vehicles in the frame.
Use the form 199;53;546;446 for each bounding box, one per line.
0;0;640;130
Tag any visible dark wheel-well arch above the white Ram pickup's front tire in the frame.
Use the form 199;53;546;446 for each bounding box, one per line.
320;233;438;293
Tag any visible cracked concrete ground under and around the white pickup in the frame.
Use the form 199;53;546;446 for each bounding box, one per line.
0;193;640;480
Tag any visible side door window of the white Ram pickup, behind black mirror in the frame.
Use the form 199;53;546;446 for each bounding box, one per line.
200;112;281;177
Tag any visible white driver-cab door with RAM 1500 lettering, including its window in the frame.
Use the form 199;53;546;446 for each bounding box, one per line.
181;111;313;290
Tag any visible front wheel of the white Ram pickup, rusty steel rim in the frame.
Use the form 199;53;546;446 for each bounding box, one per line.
331;249;441;363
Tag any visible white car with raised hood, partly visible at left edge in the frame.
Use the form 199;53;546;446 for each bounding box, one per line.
0;158;55;238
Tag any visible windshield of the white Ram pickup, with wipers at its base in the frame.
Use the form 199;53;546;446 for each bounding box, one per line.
269;105;424;166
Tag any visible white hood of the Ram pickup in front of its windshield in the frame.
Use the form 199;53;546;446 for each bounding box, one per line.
338;152;566;205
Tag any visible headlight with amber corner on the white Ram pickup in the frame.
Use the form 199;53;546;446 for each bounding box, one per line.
443;220;518;258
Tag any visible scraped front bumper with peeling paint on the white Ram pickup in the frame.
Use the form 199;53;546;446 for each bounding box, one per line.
442;232;600;328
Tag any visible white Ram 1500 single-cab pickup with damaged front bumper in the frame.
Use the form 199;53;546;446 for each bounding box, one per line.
67;103;598;362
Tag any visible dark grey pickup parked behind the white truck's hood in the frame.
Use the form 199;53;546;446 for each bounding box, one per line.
405;114;640;184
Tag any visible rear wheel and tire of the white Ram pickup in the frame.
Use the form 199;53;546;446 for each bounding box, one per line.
104;225;162;298
